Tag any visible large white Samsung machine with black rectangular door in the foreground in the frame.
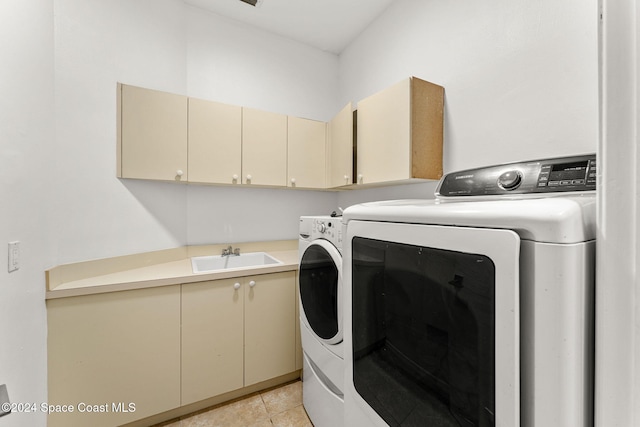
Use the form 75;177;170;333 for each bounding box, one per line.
343;155;596;427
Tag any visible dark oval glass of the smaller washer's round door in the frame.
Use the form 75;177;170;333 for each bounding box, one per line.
299;245;339;340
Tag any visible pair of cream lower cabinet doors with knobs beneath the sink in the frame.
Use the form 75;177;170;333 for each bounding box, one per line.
182;272;296;405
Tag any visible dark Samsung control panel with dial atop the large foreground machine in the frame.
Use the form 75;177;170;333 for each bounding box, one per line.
436;154;596;197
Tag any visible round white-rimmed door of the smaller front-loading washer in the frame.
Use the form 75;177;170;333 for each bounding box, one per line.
298;239;342;344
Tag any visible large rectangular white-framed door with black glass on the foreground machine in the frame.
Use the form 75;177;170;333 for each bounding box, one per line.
344;221;521;427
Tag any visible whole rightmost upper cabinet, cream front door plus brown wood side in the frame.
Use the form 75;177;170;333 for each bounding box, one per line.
357;77;444;184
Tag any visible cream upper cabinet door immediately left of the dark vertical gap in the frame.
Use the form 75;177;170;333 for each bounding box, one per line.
327;103;353;188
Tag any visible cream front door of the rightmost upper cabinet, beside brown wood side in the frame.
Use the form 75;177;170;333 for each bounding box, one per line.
357;79;411;184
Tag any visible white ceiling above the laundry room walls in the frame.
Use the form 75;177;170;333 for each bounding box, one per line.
183;0;394;54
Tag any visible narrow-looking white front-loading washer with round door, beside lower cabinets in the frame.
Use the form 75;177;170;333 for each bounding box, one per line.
298;216;344;427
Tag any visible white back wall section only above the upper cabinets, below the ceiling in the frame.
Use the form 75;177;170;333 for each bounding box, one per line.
187;7;341;121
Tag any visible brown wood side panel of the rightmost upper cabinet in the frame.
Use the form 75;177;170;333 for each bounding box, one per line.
411;77;444;179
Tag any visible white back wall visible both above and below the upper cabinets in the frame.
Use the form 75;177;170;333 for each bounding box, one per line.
182;8;339;245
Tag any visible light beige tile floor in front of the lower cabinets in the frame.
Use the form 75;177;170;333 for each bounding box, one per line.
155;381;313;427
